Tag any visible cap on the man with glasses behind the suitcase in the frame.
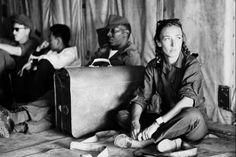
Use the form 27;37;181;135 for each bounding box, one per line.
106;15;130;28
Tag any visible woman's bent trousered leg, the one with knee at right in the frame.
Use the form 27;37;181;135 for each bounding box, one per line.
153;108;208;142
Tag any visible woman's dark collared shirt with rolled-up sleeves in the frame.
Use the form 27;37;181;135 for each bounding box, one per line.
132;53;203;113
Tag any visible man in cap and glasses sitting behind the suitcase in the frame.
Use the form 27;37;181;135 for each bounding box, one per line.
89;15;141;66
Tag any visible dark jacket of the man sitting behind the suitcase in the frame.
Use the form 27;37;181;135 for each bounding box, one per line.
92;42;141;66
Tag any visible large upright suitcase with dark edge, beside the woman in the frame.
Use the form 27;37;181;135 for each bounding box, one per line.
54;66;144;138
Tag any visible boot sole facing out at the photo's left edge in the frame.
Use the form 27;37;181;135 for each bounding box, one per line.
0;105;14;138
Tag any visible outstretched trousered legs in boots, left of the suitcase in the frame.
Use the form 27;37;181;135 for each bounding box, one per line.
0;91;54;135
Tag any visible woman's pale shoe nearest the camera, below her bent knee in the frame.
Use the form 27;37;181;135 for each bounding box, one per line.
157;138;182;153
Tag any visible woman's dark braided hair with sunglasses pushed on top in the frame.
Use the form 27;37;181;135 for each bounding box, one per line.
154;19;190;57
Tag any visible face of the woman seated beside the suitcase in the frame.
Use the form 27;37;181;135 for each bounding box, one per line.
157;25;183;57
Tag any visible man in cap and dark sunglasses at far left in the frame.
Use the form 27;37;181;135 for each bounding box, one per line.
0;14;39;104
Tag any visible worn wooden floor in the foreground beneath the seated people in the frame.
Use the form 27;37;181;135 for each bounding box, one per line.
0;122;236;157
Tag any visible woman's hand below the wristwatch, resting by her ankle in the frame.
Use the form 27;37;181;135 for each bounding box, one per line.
138;122;159;141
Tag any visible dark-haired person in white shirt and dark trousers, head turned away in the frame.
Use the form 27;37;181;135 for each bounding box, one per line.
20;24;81;101
